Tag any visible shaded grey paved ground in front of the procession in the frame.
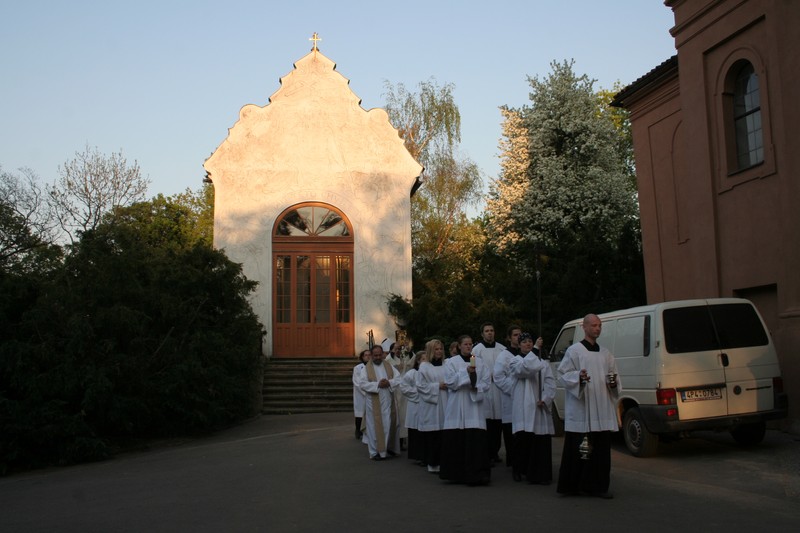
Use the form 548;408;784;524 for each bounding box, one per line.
0;413;800;533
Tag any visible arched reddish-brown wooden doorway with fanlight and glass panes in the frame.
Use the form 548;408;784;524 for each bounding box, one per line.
272;202;355;357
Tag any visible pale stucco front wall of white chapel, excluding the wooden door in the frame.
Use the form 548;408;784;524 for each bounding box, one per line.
204;51;422;356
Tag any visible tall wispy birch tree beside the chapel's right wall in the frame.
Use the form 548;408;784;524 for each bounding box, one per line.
385;79;483;341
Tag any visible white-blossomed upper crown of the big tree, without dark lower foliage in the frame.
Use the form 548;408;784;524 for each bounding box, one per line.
488;62;638;270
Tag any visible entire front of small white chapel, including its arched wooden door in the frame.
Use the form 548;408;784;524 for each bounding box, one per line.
204;40;422;357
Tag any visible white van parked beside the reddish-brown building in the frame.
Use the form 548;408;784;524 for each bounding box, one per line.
549;298;788;457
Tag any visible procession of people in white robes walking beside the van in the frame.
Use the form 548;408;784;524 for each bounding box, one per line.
353;315;621;498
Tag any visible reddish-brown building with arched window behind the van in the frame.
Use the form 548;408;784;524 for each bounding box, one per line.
612;0;800;424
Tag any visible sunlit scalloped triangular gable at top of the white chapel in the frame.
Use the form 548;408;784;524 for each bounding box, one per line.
204;51;422;183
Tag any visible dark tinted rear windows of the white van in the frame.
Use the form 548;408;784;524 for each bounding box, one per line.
663;303;769;353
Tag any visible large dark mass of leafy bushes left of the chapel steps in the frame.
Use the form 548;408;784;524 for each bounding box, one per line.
0;193;262;472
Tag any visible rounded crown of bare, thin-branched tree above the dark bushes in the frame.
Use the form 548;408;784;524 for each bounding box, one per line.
47;141;149;242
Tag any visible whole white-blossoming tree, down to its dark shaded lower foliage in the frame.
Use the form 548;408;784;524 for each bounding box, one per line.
487;62;644;334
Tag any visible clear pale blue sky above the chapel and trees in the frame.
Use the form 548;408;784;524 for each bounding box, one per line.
0;0;675;204
